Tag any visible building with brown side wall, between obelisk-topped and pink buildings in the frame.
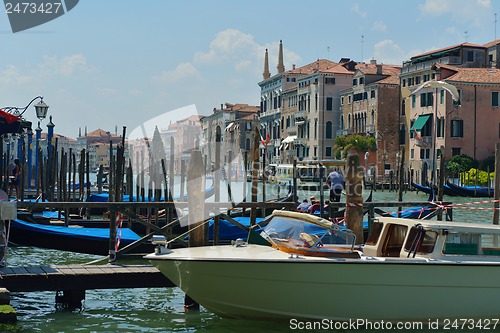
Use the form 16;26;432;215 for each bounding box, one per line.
338;59;401;181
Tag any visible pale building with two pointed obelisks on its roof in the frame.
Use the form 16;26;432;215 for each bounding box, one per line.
258;41;356;163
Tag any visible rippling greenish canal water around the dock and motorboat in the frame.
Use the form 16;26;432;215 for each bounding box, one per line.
0;187;500;333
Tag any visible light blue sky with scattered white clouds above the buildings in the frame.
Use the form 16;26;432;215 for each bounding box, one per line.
0;0;500;138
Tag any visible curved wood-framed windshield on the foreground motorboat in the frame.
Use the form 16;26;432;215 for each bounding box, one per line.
261;216;356;250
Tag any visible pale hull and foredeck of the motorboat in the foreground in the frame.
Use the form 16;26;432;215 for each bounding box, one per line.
147;245;500;321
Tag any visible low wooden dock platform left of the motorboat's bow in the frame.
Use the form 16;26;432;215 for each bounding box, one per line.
0;265;174;292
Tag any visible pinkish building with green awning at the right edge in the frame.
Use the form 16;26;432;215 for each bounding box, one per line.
400;41;500;184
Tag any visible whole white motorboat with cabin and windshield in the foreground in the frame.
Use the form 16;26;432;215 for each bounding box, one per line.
147;211;500;322
